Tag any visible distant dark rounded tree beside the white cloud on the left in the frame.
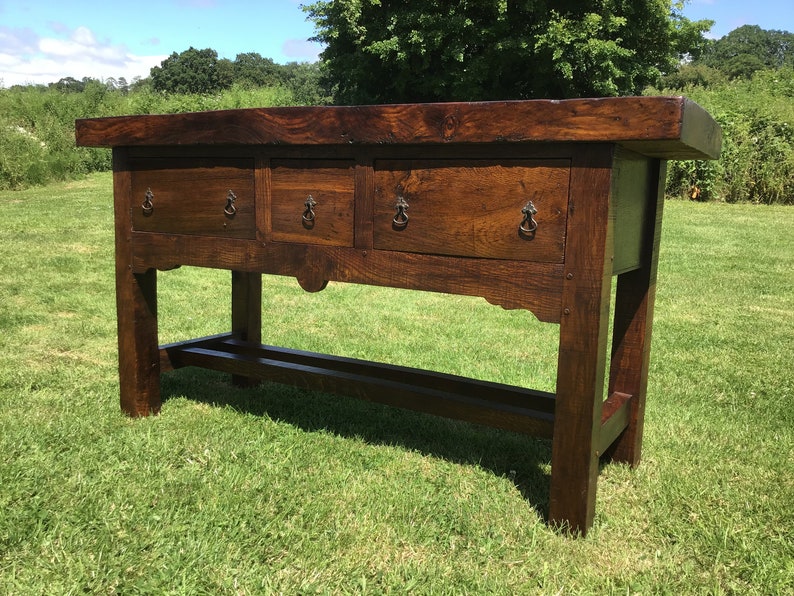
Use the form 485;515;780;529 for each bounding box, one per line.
150;47;231;93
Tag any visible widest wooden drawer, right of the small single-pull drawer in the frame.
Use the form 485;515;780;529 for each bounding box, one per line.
374;159;570;263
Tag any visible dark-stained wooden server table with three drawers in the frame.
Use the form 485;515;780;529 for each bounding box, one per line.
77;97;721;533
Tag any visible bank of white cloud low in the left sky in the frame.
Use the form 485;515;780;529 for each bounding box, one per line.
0;27;167;87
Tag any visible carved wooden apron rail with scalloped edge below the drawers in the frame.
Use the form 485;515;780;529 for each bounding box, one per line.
128;232;563;323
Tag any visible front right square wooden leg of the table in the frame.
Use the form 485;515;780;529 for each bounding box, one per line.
549;146;614;535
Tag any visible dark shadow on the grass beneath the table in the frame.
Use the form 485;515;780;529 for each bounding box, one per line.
161;368;551;520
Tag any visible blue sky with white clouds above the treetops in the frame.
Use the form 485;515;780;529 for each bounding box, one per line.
0;0;794;87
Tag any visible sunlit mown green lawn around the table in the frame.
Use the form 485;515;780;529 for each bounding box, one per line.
0;174;794;594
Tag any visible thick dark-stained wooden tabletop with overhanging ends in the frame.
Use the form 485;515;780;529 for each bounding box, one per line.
76;97;722;159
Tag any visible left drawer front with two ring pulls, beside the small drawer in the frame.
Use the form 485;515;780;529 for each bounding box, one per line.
130;157;256;239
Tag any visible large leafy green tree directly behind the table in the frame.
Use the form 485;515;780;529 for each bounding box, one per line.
304;0;711;103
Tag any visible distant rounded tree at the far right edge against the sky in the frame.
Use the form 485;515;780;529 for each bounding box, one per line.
702;25;794;79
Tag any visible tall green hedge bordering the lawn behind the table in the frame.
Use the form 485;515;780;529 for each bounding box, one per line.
0;65;794;204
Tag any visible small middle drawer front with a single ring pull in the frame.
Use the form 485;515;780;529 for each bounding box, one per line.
270;159;355;246
